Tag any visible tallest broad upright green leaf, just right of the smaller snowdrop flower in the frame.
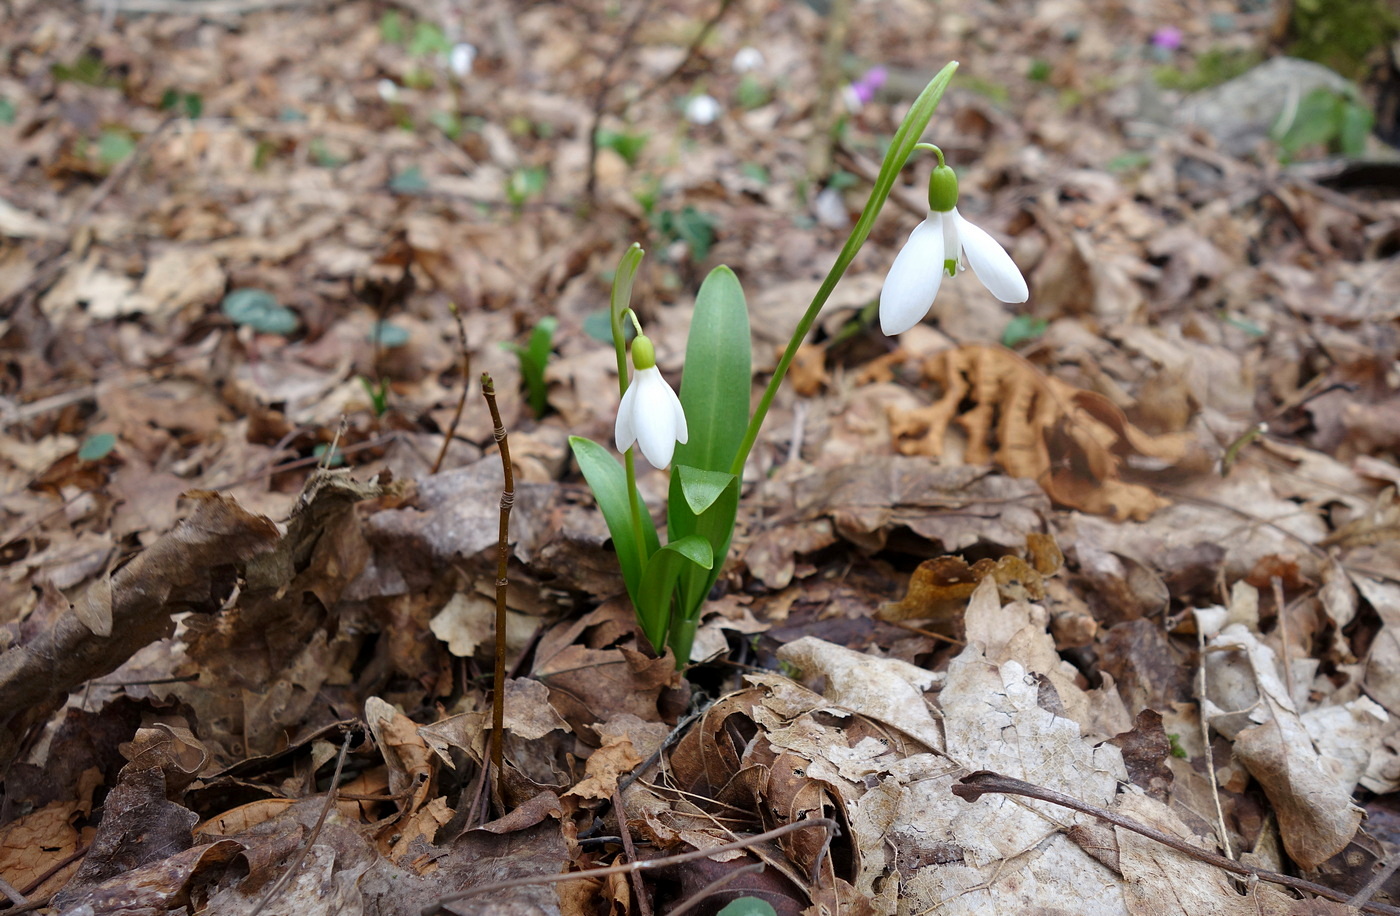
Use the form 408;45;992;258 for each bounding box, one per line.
672;266;753;471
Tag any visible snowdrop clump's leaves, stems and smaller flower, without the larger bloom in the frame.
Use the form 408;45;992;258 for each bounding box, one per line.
568;63;963;667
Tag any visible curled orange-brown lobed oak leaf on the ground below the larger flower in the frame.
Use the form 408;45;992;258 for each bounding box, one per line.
889;345;1190;521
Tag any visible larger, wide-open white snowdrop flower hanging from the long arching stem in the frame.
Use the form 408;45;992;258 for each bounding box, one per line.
879;155;1030;336
